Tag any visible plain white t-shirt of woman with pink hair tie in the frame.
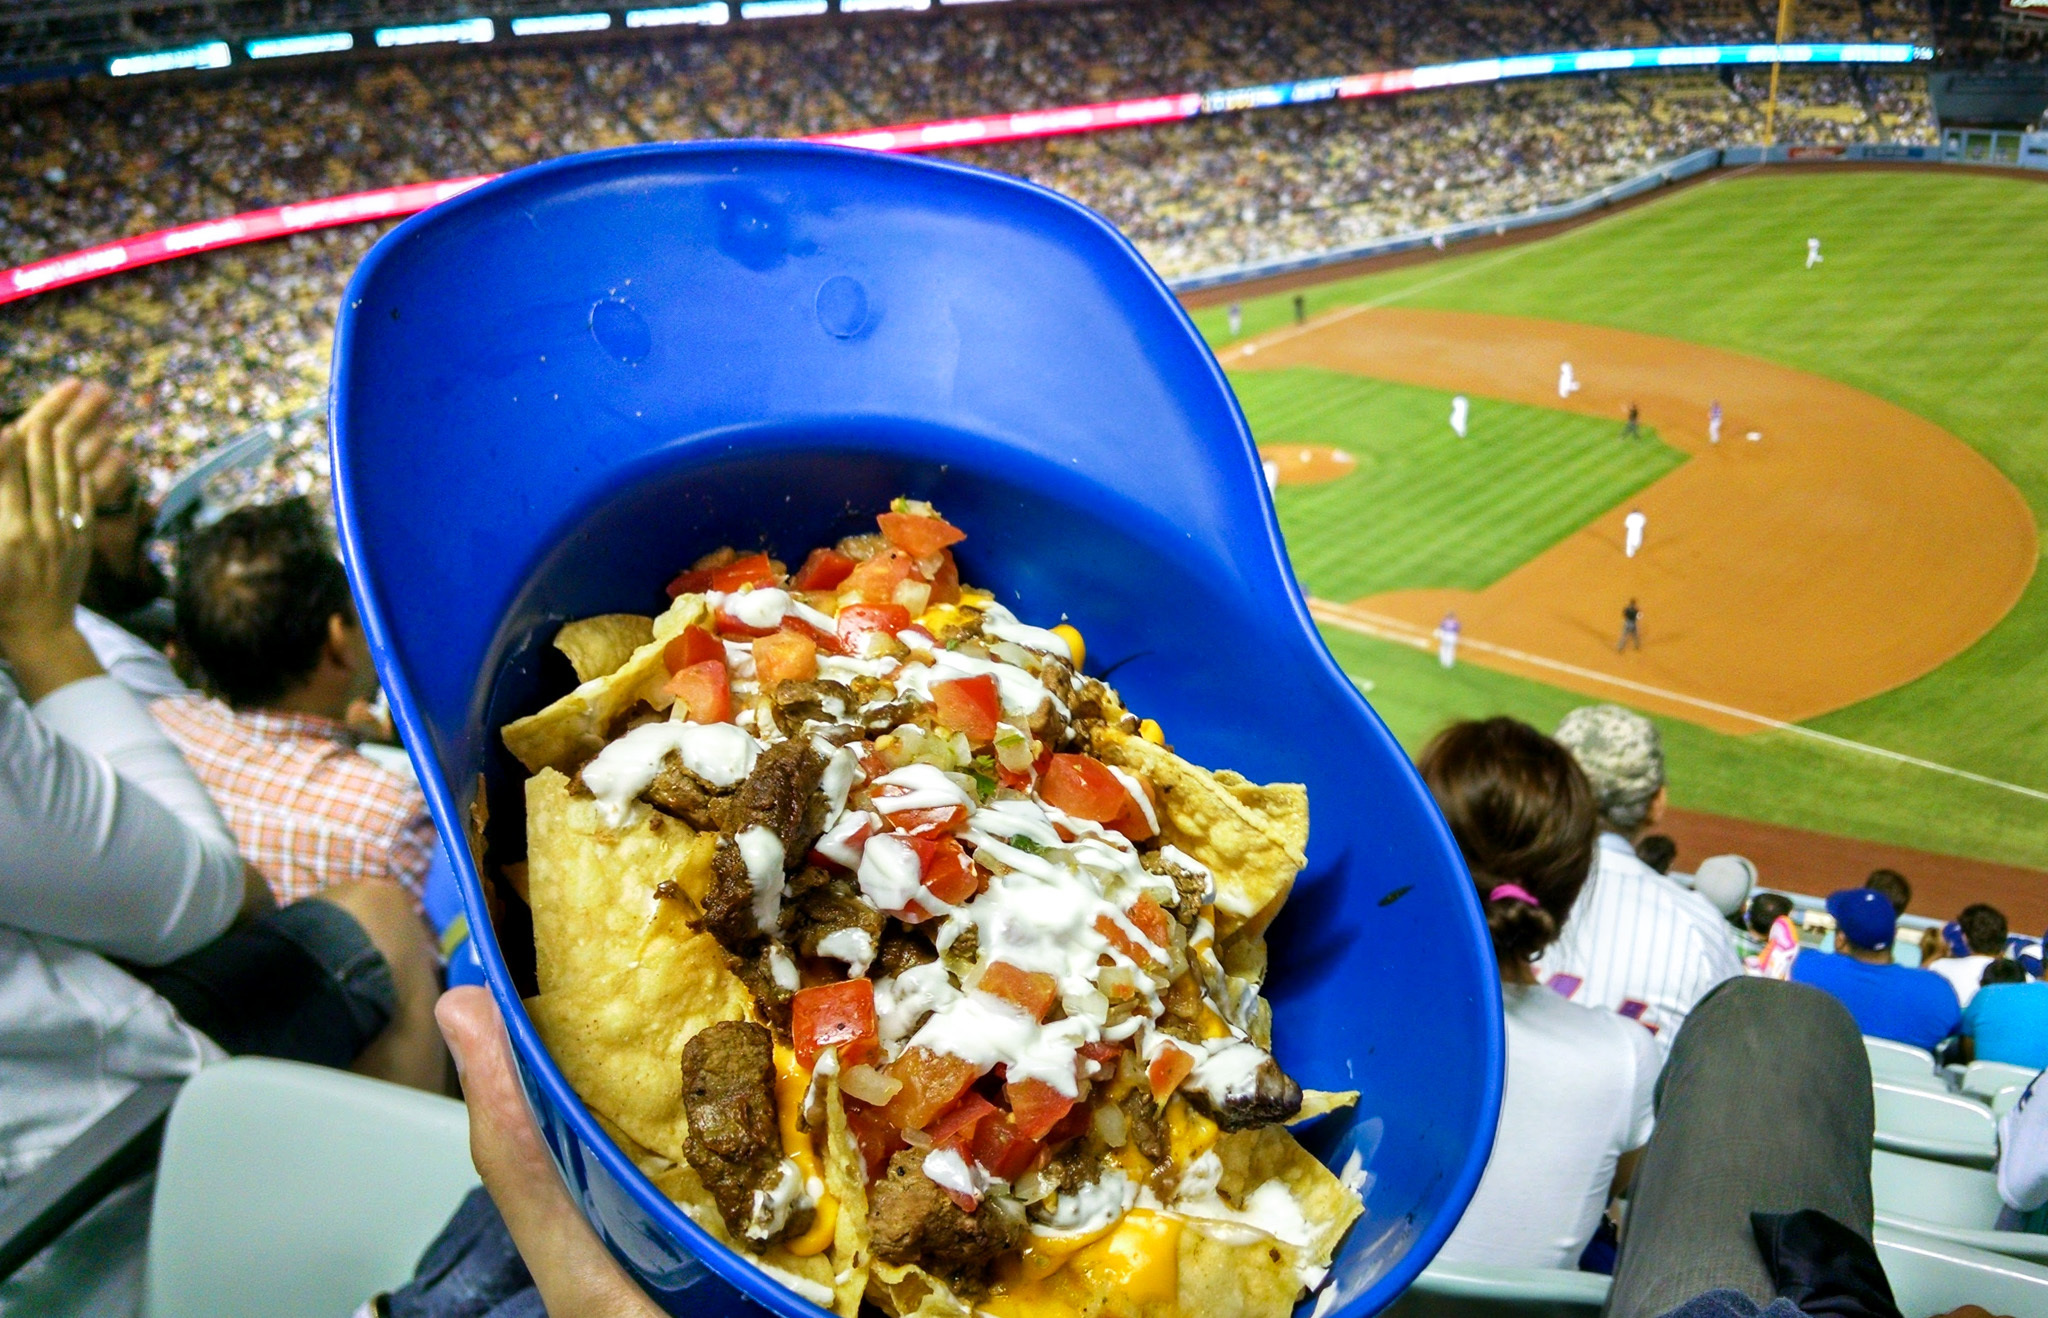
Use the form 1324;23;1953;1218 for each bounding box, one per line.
1440;984;1663;1269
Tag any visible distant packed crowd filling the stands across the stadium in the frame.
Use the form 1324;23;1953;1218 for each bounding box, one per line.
0;0;1931;509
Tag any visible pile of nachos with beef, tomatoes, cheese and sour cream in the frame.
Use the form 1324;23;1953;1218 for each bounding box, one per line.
504;499;1362;1318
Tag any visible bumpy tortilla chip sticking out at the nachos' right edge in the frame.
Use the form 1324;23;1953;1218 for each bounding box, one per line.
1094;729;1309;941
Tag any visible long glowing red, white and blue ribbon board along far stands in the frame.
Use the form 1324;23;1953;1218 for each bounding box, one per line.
0;41;1933;303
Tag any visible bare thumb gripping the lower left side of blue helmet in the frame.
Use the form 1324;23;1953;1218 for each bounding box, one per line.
434;984;662;1318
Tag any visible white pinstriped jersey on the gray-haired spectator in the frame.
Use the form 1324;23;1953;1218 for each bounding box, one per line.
1536;833;1743;1052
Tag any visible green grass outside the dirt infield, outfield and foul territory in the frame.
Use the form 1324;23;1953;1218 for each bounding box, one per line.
1196;168;2048;866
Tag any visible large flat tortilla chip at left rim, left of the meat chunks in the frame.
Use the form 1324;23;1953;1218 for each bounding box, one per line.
526;770;723;994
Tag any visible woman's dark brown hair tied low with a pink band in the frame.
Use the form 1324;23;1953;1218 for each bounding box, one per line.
1419;718;1599;966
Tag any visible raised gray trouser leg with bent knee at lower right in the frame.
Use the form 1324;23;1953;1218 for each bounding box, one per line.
1606;978;1872;1318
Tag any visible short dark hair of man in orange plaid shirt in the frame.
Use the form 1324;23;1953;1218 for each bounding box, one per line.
178;499;354;708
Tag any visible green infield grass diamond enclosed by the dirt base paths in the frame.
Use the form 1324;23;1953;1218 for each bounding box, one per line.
1233;366;1686;600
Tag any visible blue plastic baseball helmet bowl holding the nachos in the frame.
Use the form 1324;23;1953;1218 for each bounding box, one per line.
332;143;1501;1314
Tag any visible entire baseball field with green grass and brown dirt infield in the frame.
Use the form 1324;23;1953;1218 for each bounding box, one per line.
1196;168;2048;888
